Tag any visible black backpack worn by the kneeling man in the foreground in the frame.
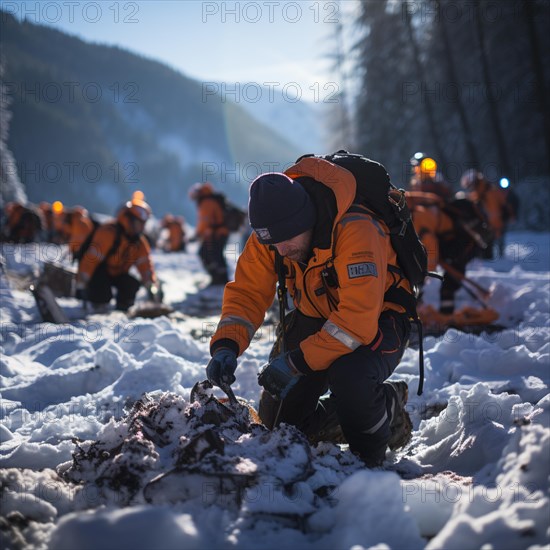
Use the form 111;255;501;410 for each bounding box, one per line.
298;150;428;286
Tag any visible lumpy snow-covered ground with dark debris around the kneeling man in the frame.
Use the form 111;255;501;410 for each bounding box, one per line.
0;233;550;550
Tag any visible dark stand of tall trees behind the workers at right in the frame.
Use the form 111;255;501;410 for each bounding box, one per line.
356;0;550;229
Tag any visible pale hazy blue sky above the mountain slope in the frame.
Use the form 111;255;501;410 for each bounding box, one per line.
4;0;357;100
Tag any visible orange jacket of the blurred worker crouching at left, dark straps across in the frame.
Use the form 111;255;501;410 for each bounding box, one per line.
77;222;156;284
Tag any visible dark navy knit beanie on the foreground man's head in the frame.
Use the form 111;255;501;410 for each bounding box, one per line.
248;172;317;244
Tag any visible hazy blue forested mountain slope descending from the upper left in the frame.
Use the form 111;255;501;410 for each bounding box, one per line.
0;11;310;221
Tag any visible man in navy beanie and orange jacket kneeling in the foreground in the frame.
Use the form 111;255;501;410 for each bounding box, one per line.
206;166;412;467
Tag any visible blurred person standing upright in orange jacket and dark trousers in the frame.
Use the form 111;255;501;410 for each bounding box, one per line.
189;182;229;285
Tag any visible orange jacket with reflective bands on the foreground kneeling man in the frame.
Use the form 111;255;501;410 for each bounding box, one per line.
211;157;410;370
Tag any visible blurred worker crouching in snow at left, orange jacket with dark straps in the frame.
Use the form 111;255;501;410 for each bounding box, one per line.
76;199;157;311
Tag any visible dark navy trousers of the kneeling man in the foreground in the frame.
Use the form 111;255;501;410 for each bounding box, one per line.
259;311;410;466
